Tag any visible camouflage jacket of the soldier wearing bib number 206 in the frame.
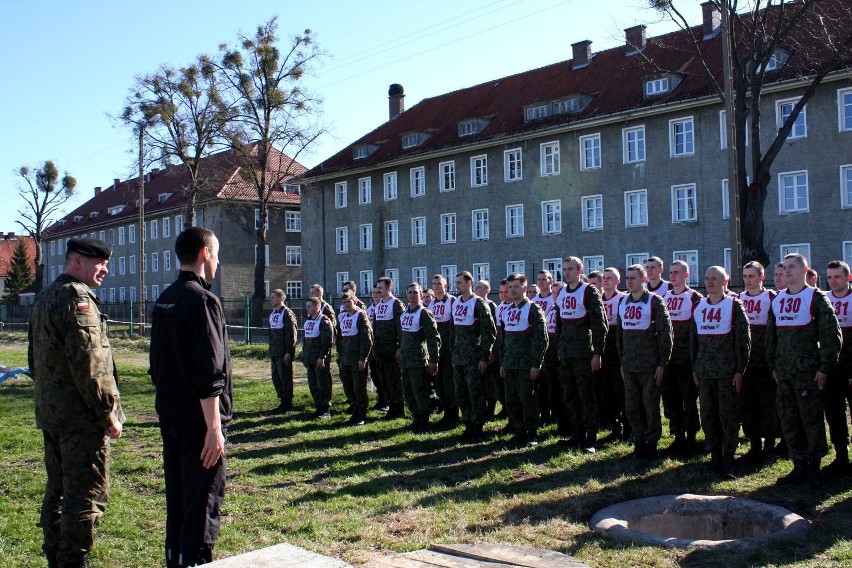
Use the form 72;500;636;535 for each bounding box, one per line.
616;291;673;373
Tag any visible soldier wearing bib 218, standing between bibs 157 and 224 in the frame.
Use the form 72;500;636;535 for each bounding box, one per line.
396;282;441;434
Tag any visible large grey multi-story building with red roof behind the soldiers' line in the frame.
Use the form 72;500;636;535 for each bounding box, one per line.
302;3;852;290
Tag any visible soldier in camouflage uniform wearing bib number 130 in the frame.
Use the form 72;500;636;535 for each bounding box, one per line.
766;254;841;487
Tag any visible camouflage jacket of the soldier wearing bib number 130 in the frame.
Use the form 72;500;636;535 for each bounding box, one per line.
766;288;842;376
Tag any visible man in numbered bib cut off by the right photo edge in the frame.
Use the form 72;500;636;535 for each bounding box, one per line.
825;260;852;473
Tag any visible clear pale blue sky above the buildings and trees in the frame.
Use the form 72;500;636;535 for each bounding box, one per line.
0;0;701;233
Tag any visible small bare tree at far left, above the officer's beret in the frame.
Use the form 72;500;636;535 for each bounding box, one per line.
16;160;77;291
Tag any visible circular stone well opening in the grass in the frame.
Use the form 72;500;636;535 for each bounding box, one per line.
590;494;811;548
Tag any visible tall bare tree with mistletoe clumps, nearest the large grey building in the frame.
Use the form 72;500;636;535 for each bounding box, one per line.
215;18;325;299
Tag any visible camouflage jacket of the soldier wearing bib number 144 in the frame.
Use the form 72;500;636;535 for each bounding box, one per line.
689;298;751;379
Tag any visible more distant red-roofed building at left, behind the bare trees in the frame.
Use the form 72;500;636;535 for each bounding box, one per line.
43;151;305;303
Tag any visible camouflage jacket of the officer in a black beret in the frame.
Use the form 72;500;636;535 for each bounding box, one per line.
28;274;125;432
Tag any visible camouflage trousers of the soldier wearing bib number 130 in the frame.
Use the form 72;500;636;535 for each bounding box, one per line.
776;373;828;460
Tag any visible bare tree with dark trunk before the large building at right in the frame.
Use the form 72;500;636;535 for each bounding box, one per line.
646;0;852;265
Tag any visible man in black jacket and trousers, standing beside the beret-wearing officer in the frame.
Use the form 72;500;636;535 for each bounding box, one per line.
150;227;234;567
